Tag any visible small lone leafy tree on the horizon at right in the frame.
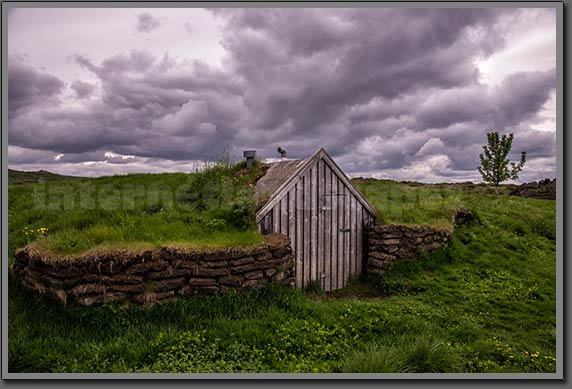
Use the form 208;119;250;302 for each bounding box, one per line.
478;132;526;195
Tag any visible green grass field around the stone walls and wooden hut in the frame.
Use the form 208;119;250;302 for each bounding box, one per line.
8;169;556;373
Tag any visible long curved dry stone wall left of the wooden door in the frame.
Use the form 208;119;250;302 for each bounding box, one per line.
12;234;295;305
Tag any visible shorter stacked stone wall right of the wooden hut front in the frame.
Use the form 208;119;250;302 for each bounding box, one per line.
367;224;451;274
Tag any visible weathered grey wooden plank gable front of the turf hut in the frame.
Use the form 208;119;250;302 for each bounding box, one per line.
256;149;376;291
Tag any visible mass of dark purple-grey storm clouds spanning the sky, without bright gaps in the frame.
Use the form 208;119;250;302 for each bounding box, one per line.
9;9;555;177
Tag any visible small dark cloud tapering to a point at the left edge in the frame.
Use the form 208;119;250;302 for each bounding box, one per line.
8;56;65;118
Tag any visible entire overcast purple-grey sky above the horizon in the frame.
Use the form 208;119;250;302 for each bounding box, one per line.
8;8;556;182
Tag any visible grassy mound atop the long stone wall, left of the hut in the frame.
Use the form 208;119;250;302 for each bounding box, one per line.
8;163;264;260
